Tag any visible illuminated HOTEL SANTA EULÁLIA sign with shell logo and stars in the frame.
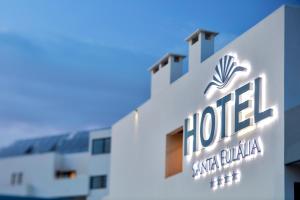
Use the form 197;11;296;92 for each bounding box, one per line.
184;55;275;189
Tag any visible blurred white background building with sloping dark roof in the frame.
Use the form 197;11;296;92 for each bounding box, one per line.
0;129;111;200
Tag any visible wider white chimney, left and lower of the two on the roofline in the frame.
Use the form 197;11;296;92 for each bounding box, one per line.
148;53;185;97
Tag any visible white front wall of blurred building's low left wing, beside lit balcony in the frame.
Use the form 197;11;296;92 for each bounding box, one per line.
0;153;88;197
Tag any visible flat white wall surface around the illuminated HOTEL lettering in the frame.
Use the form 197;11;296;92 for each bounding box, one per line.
105;7;285;200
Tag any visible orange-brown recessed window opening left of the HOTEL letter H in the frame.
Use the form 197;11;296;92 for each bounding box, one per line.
165;127;183;178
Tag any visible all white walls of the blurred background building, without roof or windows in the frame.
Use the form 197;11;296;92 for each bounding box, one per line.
0;129;110;200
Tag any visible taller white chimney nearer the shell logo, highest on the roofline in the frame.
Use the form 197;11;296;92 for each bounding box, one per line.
185;29;218;68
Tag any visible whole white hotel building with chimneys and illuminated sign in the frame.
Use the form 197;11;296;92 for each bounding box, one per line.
105;6;300;200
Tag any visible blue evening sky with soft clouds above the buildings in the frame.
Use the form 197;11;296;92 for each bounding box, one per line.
0;0;300;146
